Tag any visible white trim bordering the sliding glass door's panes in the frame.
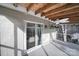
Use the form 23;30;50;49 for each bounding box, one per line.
24;20;44;52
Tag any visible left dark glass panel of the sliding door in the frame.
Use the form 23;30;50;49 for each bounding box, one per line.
27;23;35;49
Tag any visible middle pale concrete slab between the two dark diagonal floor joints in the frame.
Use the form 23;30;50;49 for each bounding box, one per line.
43;43;67;56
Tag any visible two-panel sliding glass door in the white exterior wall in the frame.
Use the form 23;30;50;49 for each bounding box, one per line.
26;22;43;49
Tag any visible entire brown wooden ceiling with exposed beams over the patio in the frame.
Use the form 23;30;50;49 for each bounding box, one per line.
20;3;79;22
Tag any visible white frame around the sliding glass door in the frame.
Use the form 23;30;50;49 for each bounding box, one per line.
24;20;44;51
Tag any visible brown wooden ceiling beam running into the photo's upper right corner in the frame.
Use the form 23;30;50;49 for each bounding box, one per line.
44;4;79;16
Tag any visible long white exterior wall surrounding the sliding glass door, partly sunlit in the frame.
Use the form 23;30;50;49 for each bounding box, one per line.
0;7;55;56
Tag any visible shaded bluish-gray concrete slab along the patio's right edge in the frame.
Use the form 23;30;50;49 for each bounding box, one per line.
52;42;79;56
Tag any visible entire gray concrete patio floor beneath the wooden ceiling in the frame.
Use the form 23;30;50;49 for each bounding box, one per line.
27;41;79;56
